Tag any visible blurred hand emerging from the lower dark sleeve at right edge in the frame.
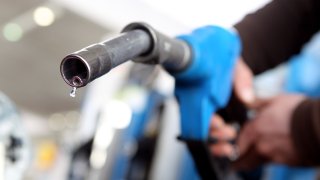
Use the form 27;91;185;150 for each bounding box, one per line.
234;94;305;170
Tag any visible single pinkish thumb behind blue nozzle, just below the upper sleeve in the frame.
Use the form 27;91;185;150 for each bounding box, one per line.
234;59;255;106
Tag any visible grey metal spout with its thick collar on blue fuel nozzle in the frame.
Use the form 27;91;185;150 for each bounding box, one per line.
60;23;191;88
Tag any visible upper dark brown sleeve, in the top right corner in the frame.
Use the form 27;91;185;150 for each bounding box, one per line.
235;0;320;74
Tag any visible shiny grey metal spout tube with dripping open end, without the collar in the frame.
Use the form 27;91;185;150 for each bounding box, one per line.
60;30;152;87
